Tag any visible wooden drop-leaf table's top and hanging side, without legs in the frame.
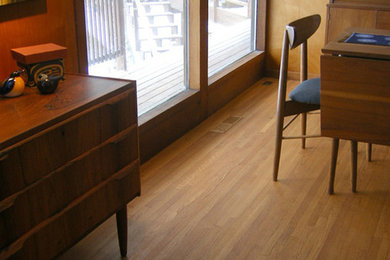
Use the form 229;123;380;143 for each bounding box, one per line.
321;28;390;145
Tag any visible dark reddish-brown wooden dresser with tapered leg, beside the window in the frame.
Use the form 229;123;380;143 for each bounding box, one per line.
0;74;140;260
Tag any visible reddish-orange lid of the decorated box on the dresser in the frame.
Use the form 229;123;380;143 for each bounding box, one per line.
11;43;67;64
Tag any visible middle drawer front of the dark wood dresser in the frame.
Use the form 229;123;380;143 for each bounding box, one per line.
0;126;138;248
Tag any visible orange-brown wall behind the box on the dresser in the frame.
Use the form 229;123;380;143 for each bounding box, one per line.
0;0;79;80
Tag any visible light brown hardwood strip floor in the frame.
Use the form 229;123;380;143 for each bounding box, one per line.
60;79;390;260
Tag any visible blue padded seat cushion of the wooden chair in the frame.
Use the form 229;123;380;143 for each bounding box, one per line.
288;78;321;105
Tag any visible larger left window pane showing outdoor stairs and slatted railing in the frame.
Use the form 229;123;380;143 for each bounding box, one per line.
85;0;187;115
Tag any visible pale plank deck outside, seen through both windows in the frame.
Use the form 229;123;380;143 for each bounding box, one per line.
89;21;251;115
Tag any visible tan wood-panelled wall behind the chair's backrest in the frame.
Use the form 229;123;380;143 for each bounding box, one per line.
266;0;329;76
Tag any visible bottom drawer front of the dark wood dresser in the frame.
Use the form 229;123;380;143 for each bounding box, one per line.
0;162;140;260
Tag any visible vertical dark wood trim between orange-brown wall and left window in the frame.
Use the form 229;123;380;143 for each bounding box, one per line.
74;0;88;74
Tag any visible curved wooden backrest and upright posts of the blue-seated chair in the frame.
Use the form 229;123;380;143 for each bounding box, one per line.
278;14;321;110
